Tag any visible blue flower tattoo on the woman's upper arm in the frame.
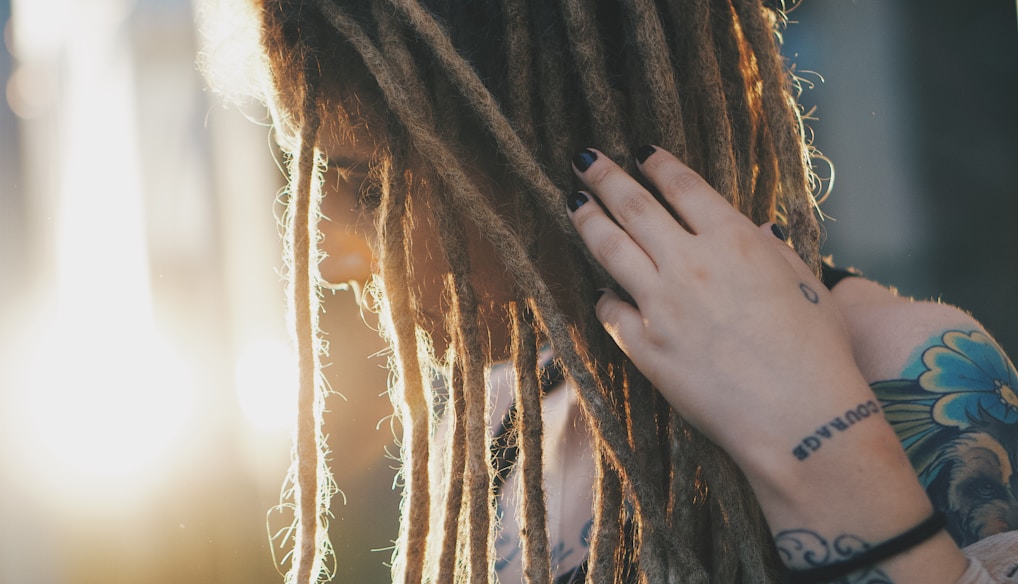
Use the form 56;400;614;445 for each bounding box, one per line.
872;331;1018;545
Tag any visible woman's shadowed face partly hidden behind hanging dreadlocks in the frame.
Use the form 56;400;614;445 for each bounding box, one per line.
319;124;512;359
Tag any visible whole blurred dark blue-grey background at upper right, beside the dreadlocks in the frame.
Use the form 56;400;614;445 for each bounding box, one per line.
785;0;1018;355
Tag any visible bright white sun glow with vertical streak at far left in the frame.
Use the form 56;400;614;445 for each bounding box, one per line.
5;0;196;494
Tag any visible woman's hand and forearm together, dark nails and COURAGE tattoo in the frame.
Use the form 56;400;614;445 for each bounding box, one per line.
568;147;965;583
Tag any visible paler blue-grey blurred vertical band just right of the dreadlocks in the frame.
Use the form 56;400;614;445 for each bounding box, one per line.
784;0;931;297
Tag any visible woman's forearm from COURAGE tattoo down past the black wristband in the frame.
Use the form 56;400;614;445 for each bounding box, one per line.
736;376;967;584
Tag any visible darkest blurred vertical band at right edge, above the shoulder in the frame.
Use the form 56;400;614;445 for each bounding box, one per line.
902;0;1018;357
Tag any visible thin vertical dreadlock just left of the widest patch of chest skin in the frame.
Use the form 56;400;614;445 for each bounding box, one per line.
509;301;552;584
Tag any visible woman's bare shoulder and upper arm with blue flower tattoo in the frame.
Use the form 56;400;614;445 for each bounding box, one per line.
832;278;1018;545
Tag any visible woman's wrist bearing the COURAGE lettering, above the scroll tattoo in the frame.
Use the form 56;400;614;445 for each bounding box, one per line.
733;377;931;536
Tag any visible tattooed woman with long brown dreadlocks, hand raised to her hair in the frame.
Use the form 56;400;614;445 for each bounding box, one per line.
244;0;1018;583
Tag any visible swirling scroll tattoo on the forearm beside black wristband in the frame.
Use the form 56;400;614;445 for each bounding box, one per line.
774;529;894;584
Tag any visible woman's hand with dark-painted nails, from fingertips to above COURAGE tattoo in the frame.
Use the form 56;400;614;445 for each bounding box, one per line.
570;149;873;472
